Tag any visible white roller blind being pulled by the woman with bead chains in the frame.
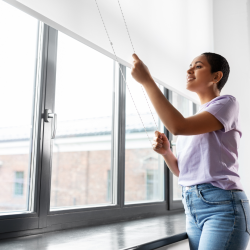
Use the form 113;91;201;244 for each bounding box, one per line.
5;0;213;103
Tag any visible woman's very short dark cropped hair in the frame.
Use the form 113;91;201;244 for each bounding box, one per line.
202;52;230;91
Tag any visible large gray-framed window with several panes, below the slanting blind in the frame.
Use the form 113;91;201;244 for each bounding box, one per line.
0;1;201;238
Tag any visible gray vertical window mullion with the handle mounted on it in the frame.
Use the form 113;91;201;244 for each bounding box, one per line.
39;25;58;228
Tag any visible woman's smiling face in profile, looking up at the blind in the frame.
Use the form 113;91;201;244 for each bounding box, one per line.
186;55;217;93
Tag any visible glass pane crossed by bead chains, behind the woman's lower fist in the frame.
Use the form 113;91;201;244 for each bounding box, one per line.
125;69;164;203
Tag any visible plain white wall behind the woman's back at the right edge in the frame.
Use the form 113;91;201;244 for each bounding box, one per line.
213;0;250;198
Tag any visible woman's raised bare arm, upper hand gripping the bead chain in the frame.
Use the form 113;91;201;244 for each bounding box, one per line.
131;54;223;135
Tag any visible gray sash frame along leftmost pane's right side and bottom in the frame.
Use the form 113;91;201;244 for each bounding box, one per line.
0;21;48;236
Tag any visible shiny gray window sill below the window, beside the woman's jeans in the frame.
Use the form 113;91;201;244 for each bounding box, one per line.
0;212;187;250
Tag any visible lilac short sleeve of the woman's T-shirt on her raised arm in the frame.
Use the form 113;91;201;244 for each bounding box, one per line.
203;97;239;132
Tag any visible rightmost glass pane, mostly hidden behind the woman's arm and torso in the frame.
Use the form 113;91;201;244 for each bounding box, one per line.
171;92;194;200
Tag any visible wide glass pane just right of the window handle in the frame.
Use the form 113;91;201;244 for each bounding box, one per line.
50;32;113;209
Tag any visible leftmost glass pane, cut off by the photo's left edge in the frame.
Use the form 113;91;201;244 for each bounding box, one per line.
0;1;38;213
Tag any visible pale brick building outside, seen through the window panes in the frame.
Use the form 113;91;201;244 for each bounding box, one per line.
0;114;179;211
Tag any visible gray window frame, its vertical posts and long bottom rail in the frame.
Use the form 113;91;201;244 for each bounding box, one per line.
0;23;190;239
